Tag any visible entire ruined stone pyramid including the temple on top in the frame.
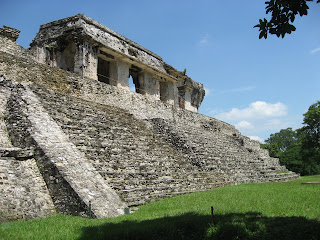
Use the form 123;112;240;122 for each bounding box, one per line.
0;15;298;219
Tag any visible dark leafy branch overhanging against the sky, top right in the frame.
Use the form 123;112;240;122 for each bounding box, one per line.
254;0;320;39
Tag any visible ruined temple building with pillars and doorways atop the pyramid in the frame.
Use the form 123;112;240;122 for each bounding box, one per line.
31;14;205;112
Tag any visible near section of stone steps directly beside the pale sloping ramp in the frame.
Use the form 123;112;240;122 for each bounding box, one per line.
29;84;225;206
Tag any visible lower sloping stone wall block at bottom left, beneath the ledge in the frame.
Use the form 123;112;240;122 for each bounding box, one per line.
0;156;55;222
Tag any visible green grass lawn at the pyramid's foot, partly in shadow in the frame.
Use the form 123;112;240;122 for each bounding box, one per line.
0;175;320;240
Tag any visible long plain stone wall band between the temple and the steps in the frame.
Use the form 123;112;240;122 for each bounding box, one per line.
0;48;248;140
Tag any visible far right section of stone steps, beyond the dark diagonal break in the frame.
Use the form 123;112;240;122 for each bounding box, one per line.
149;118;298;184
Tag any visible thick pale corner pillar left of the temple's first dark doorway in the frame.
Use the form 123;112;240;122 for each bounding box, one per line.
74;41;98;80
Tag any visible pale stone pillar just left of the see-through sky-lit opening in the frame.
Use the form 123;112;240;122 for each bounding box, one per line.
109;61;129;90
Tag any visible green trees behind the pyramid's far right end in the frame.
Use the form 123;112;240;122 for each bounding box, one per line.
262;101;320;175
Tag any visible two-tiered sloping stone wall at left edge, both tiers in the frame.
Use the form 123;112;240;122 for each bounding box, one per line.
0;85;55;222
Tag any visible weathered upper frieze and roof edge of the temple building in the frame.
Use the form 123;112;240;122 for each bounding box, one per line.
31;14;166;73
